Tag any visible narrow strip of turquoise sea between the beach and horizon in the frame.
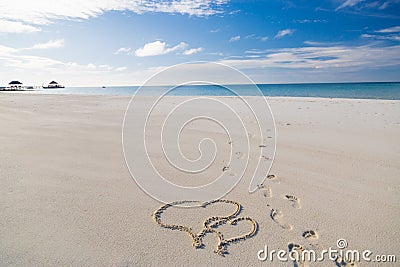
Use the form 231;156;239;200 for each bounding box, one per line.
24;82;400;100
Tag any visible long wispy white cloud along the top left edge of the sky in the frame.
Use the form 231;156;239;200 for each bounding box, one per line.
0;0;228;32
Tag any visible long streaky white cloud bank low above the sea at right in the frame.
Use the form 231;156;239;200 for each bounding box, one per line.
221;45;400;71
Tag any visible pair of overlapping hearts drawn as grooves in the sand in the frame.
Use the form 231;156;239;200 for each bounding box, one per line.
153;199;258;256
